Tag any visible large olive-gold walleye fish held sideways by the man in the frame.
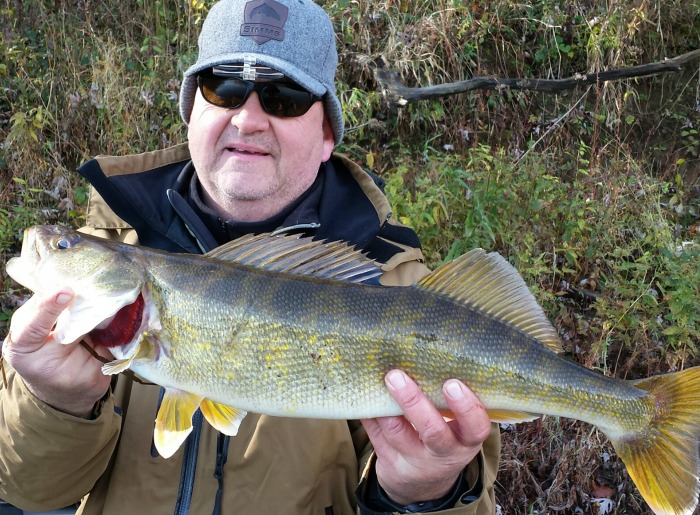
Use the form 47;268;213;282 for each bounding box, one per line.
7;226;700;515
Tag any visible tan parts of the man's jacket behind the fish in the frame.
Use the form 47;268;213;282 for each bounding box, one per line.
0;148;500;515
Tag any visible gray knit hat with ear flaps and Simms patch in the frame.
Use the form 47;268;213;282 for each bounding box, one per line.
180;0;343;144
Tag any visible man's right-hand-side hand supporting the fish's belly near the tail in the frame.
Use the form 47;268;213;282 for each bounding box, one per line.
362;370;491;505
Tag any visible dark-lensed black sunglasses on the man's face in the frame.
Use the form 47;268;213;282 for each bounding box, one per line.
197;73;322;118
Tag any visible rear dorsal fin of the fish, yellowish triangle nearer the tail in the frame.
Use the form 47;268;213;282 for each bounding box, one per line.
418;249;562;352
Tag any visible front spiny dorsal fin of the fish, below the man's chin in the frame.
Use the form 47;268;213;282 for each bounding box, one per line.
205;233;382;283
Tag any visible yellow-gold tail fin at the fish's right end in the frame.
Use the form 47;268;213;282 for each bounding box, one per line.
611;367;700;515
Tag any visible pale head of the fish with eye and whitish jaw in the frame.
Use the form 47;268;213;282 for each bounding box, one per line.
6;225;146;343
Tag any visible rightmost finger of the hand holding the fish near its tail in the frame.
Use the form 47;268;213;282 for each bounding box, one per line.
443;379;491;447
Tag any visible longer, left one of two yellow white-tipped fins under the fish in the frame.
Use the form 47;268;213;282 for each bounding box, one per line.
153;388;202;458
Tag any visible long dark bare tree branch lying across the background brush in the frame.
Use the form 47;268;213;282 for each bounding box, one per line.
360;49;700;107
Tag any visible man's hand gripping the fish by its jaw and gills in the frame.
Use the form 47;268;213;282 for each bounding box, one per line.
2;289;112;417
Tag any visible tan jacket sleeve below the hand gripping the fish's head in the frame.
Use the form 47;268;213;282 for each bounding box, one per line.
0;363;121;511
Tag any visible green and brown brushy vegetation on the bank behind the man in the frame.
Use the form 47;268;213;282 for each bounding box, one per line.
0;0;700;514
